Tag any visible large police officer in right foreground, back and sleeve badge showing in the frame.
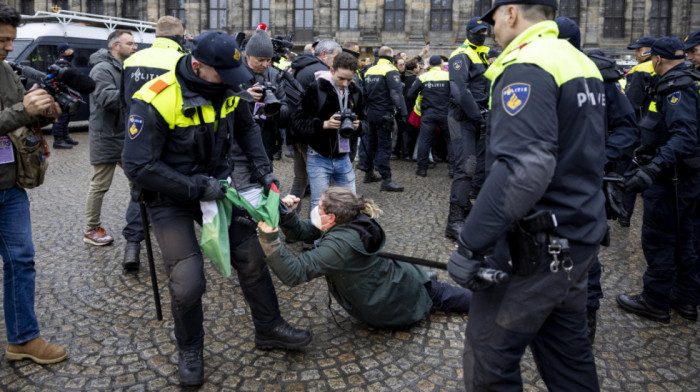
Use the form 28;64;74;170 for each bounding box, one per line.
447;0;607;391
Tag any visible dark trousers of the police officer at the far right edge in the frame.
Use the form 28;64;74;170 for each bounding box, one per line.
642;171;700;309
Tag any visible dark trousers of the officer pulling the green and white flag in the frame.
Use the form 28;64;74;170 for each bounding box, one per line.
148;200;281;350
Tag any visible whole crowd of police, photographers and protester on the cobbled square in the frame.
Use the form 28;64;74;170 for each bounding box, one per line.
0;0;700;391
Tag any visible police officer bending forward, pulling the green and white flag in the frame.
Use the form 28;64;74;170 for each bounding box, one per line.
123;31;311;386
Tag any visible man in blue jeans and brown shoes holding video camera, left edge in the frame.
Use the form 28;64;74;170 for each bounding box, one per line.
0;3;67;364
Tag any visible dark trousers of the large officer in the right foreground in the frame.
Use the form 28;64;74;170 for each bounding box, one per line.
464;243;599;392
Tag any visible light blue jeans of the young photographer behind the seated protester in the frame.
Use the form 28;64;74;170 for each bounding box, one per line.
306;147;355;208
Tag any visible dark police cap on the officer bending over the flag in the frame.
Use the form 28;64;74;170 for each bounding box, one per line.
192;31;253;87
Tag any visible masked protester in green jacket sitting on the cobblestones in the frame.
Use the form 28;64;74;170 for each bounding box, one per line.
258;187;471;328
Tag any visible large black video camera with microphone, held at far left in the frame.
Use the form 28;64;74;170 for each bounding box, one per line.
9;63;95;115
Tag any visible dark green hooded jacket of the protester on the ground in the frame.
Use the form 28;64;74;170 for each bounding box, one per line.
265;213;433;328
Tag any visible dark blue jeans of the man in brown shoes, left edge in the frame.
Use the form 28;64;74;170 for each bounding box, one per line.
0;187;39;344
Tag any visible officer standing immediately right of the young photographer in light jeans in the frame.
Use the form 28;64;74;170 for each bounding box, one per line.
360;46;408;192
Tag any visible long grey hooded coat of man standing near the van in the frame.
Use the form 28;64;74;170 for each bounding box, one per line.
88;49;126;165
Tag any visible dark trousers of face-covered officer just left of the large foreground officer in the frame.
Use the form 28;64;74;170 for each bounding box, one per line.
447;111;479;208
